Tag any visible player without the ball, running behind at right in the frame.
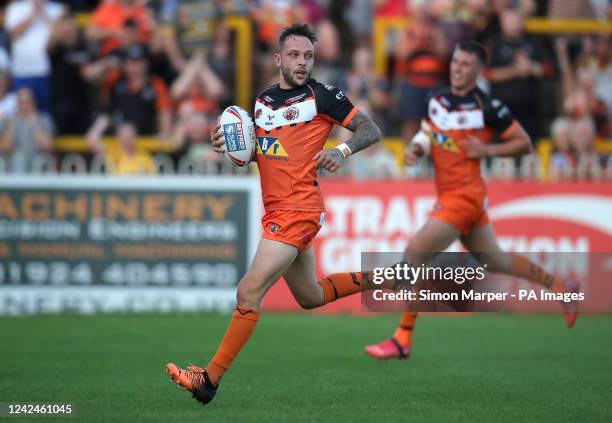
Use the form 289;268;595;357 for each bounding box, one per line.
365;41;579;359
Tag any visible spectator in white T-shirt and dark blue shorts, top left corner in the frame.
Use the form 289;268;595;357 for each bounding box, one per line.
4;0;64;111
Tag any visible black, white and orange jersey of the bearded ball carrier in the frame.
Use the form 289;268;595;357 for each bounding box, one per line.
253;79;357;211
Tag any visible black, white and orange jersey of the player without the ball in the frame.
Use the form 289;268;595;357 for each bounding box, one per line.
422;88;515;193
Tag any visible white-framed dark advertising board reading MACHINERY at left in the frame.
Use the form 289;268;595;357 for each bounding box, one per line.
0;174;261;315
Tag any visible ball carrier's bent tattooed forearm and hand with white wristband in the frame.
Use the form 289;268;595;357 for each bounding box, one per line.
313;111;382;172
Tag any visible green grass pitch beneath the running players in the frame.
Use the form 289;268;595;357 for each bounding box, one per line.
0;314;612;423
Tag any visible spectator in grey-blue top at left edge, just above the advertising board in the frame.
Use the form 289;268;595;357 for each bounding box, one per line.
0;88;53;173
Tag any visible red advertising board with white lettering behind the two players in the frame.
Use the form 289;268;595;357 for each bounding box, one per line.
264;180;612;312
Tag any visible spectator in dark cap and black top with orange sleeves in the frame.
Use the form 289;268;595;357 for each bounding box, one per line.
95;45;172;140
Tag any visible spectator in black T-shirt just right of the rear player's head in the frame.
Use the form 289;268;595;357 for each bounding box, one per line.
486;9;552;140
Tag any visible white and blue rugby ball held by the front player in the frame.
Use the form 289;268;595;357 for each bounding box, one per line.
219;106;257;166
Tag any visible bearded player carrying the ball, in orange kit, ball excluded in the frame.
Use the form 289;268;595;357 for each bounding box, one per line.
166;24;388;404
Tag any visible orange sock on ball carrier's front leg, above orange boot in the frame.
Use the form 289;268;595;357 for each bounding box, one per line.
206;306;259;384
